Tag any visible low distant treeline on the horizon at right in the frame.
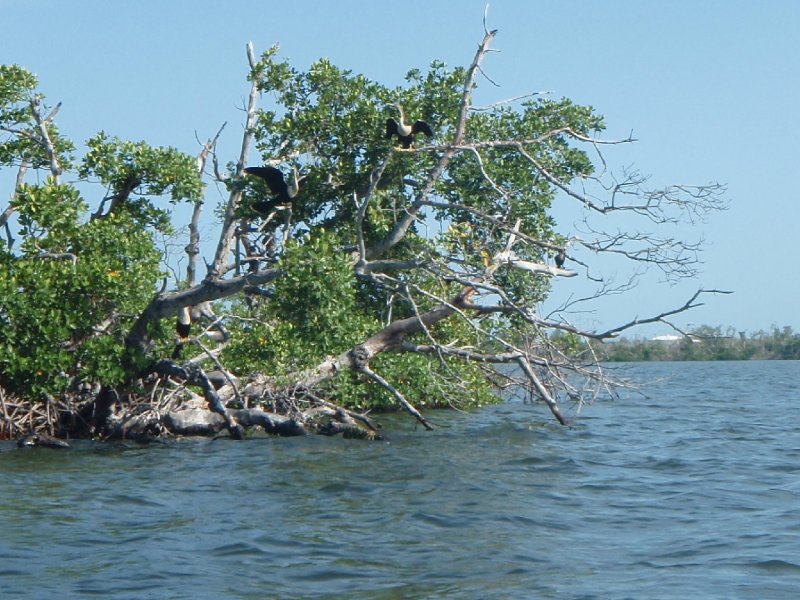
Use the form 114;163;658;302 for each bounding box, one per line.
592;325;800;362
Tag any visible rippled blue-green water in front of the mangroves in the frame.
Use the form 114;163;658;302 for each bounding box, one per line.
0;362;800;600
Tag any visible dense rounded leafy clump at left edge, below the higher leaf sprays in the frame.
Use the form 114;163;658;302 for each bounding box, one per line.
0;192;160;397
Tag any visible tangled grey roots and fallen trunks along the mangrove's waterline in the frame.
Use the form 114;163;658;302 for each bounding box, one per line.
0;360;381;448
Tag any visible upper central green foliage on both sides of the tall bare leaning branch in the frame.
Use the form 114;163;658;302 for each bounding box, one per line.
244;50;604;326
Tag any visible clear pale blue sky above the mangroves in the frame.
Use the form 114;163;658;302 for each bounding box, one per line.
0;0;800;335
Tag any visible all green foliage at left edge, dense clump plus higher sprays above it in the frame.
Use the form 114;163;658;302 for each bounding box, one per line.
0;65;181;399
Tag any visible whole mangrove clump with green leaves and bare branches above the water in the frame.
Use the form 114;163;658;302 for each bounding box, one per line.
0;31;723;437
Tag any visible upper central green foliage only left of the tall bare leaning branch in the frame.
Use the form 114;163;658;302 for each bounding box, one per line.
250;51;463;230
